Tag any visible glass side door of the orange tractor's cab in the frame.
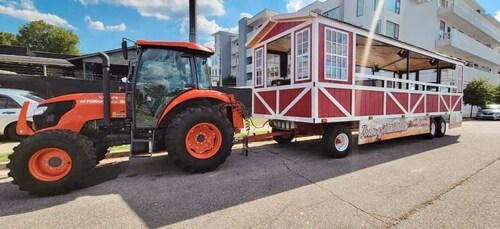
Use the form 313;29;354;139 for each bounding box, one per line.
135;48;194;127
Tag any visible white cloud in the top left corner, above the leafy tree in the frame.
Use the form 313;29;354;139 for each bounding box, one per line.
0;0;76;29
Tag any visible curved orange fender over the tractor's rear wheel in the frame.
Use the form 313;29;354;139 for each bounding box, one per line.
158;89;233;125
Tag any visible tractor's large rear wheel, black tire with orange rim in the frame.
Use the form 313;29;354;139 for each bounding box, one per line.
166;106;234;173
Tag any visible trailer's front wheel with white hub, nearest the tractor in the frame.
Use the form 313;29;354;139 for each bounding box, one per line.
322;126;352;158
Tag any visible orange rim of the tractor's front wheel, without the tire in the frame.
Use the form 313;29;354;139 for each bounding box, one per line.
28;148;73;182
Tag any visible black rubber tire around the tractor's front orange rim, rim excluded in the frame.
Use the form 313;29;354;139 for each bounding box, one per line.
7;130;96;196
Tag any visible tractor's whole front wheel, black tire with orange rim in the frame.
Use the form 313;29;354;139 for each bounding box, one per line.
7;130;96;196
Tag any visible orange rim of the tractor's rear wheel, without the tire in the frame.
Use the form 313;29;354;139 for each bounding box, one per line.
186;122;222;159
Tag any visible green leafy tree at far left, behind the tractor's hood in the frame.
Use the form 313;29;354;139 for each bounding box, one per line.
17;21;80;54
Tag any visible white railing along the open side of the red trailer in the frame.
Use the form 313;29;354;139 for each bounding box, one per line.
356;73;457;93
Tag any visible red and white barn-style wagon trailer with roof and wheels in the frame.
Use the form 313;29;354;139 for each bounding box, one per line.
246;12;463;158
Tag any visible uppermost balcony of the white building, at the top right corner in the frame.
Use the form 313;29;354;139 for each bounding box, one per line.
438;0;500;46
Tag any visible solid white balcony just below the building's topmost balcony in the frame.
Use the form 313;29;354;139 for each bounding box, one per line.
436;29;500;66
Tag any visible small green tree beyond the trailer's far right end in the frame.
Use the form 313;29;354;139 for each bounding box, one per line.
464;78;495;118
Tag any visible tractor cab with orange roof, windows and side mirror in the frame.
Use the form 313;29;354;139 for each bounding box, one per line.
122;40;213;128
